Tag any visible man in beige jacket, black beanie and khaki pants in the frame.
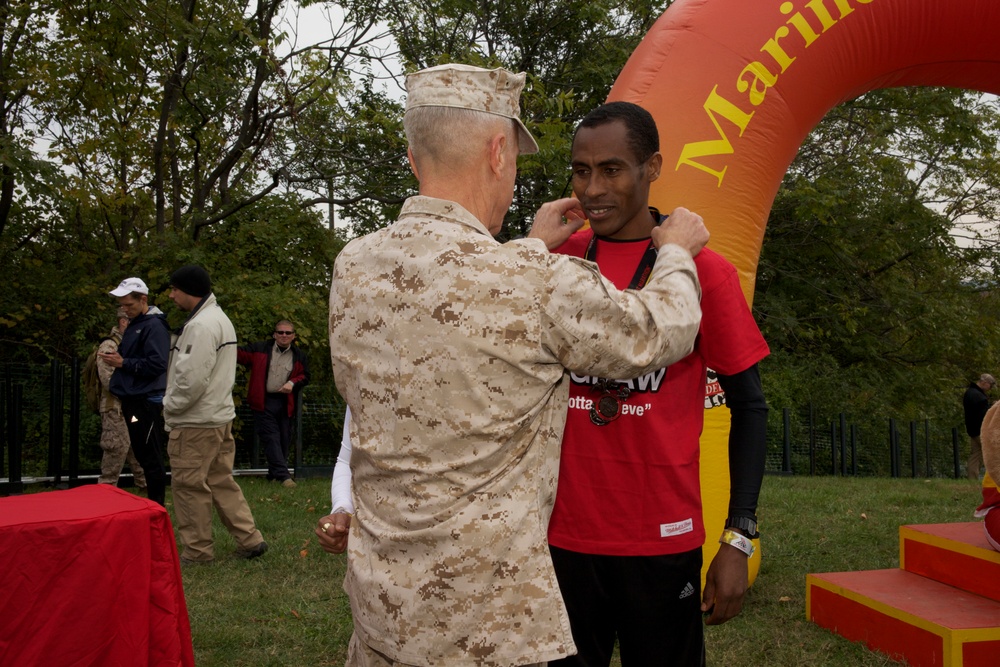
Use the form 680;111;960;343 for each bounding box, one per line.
163;265;267;565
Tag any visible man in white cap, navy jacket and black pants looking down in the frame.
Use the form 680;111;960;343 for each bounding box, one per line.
101;278;170;505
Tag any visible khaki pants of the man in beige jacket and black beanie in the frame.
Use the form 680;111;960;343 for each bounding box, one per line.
167;423;264;562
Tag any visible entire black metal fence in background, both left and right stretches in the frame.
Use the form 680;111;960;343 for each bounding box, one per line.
0;360;968;494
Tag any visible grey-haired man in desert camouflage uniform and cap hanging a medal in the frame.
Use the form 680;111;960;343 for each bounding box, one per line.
316;65;708;666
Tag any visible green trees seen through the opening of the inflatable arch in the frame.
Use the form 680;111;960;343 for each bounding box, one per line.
754;88;1000;432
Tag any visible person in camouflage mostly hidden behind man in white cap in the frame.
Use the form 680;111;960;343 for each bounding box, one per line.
97;308;146;489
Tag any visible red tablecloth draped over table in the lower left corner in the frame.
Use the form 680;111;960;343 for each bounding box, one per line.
0;484;194;667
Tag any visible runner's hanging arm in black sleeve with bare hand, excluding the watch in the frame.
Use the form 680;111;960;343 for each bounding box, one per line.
701;364;767;625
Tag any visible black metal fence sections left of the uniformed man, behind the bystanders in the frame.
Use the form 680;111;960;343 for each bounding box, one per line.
0;360;344;495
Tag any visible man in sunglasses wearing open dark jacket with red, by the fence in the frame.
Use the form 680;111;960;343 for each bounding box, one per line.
237;320;309;488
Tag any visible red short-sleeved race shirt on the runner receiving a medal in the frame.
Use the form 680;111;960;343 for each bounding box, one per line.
549;229;769;556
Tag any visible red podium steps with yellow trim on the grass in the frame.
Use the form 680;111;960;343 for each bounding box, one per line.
806;522;1000;667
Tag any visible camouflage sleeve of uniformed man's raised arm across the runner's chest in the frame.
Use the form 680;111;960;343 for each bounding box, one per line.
542;245;701;379
